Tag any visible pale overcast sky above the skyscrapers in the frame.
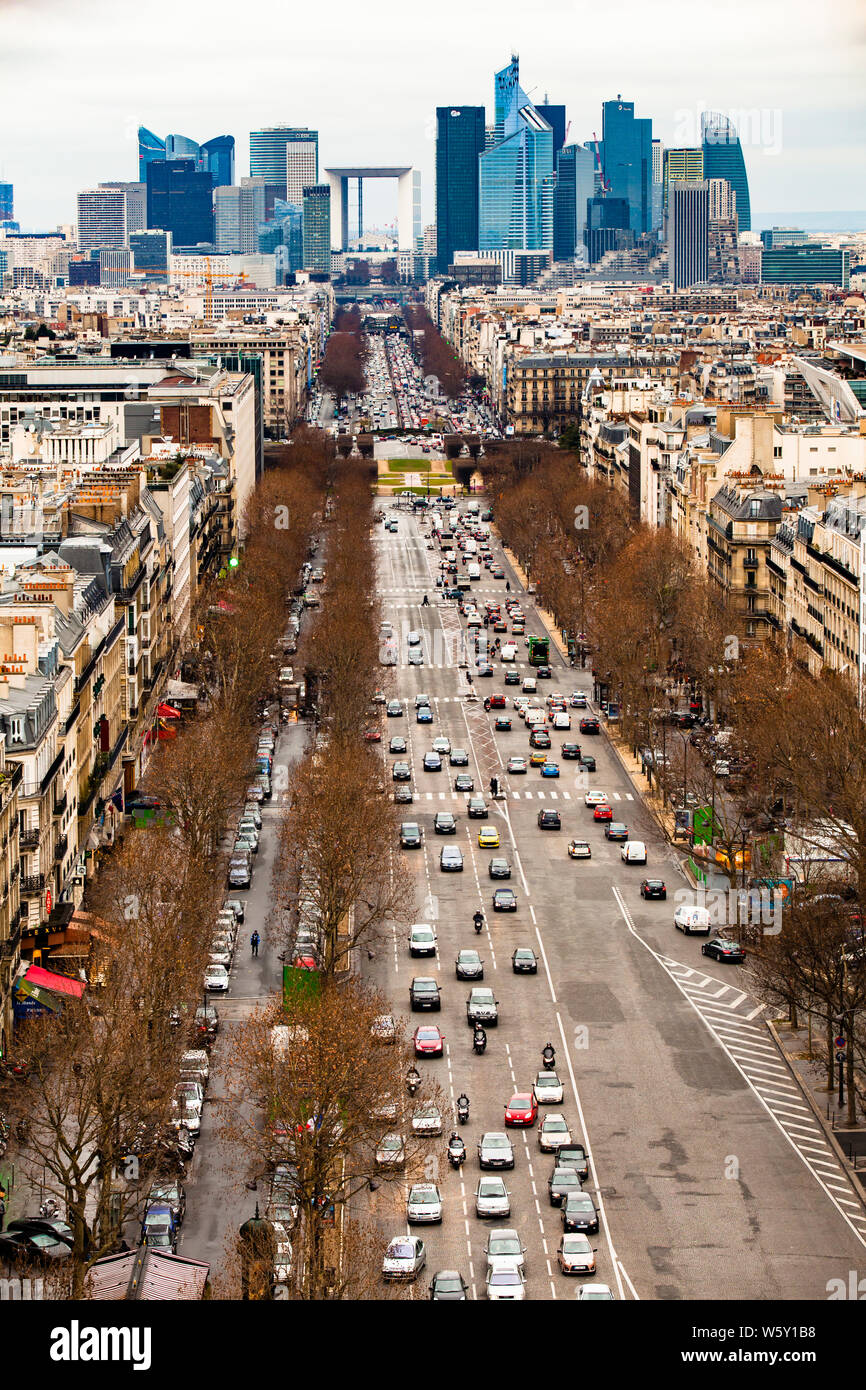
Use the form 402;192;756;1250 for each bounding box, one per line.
0;0;866;229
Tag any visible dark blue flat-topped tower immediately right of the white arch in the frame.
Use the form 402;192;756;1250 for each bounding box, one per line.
436;106;485;275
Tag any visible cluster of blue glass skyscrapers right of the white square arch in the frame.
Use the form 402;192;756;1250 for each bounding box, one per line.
436;54;751;288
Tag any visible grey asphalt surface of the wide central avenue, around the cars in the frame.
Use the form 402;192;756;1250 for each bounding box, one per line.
364;513;866;1300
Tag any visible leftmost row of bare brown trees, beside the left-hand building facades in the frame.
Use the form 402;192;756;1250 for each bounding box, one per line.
0;431;332;1298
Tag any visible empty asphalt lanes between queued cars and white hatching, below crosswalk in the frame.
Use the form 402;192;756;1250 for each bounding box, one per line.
505;795;858;1298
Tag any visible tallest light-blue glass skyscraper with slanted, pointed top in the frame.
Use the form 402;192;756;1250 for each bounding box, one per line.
478;57;556;253
